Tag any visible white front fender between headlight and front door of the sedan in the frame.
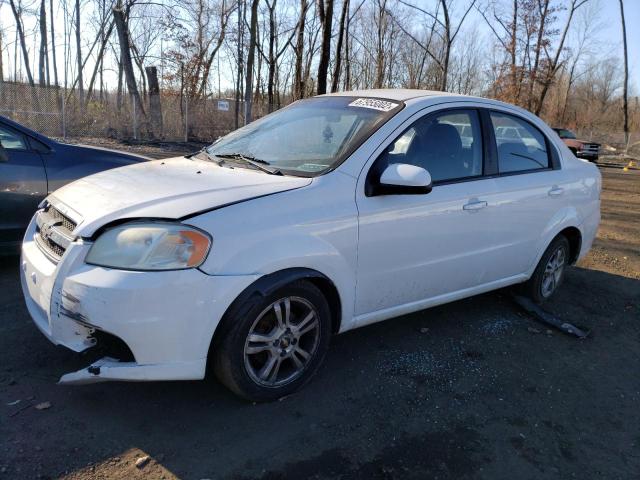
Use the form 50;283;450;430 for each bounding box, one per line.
189;176;358;329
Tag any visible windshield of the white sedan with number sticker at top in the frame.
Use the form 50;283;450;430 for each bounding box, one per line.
206;96;403;176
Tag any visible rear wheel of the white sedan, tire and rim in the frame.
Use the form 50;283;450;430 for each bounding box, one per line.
523;235;570;305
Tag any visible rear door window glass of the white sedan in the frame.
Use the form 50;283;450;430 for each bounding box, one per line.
490;112;550;173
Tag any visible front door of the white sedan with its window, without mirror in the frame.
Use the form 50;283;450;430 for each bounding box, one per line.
355;107;497;324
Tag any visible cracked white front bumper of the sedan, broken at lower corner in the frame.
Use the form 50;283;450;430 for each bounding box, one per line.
21;216;258;384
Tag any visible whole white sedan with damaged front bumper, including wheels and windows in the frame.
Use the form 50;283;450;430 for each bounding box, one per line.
21;90;601;401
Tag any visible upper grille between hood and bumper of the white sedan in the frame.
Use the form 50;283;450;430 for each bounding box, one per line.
35;205;76;263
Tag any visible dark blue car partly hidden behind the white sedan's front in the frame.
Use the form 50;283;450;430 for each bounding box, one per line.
0;116;148;255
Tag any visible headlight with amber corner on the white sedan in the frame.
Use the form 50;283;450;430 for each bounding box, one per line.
86;222;211;270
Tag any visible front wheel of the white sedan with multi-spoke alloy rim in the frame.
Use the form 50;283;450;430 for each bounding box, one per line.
212;280;331;402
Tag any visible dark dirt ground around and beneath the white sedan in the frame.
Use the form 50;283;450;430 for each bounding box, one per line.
0;152;640;480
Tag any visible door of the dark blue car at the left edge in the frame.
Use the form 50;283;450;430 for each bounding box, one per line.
0;123;47;247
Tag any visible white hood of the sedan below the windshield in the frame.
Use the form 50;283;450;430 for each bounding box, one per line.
47;157;311;237
